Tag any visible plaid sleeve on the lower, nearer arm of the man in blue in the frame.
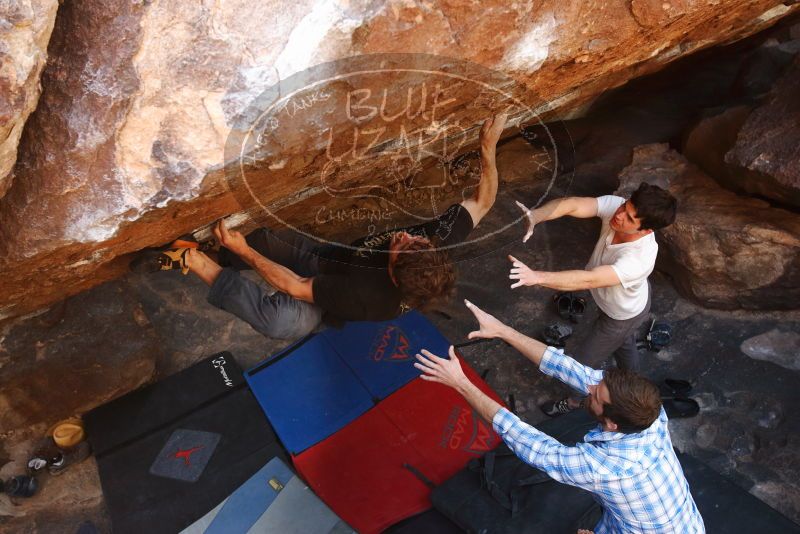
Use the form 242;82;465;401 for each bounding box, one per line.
492;408;594;489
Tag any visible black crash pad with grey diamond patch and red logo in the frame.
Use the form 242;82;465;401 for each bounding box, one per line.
81;353;286;534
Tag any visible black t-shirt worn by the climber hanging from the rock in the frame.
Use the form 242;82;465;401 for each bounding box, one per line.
312;204;473;326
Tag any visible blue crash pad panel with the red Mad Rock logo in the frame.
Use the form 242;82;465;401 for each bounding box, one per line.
320;311;450;400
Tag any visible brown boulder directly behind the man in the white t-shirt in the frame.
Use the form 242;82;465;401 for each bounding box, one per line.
620;144;800;310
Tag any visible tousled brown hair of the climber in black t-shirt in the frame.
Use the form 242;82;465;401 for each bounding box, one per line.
392;241;456;310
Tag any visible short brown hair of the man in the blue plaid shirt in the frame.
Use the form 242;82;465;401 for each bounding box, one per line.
603;369;661;434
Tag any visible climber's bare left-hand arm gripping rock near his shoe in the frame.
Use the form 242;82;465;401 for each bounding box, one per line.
214;220;314;303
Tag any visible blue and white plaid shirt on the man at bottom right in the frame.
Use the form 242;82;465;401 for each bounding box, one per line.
493;347;705;534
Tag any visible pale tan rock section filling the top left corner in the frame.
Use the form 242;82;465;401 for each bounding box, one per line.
0;0;58;197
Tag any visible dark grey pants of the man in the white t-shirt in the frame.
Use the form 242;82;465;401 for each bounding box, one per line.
573;288;650;372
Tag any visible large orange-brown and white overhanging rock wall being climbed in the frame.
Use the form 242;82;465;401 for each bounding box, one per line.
0;0;800;319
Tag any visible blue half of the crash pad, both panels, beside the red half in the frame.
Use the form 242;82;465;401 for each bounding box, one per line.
245;312;450;455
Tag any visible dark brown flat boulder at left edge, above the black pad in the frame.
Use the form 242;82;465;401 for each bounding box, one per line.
0;282;160;436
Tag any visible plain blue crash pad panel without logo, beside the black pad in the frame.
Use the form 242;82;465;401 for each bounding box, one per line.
245;336;373;454
